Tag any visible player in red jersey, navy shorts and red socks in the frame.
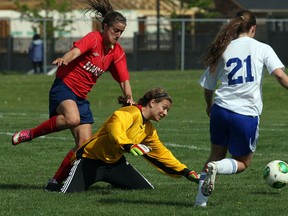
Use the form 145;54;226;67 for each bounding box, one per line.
12;0;134;190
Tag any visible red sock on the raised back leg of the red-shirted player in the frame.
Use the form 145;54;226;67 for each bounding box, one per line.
30;116;59;139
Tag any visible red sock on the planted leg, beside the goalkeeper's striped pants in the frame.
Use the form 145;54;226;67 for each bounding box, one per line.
53;150;75;183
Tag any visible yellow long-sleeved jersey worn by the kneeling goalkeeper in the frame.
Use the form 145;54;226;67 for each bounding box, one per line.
75;106;187;177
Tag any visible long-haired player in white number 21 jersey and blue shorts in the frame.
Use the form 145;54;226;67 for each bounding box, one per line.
195;11;288;207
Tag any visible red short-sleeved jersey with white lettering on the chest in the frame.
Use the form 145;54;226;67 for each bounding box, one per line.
56;31;129;98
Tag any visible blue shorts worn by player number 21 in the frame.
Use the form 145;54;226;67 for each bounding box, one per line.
210;104;260;156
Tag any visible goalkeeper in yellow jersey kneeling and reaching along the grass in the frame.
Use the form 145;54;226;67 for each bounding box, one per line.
60;88;199;193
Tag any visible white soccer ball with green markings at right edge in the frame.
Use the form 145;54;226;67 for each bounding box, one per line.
263;160;288;188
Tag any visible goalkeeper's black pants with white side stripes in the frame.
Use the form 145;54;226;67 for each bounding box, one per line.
61;156;154;193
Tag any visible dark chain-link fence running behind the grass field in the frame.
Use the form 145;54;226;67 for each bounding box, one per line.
0;19;288;73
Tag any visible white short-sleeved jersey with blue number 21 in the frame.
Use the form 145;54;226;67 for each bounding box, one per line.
199;37;284;116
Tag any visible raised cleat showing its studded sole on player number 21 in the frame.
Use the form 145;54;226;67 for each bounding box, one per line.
201;162;217;196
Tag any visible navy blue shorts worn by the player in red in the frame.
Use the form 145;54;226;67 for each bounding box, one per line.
49;78;94;124
